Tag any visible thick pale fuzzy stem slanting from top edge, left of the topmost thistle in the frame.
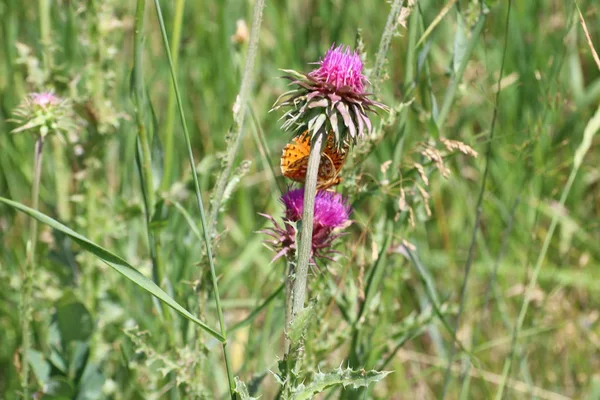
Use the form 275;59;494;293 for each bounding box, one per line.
208;0;265;234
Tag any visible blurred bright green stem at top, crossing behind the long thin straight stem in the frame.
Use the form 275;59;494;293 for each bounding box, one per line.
161;0;185;190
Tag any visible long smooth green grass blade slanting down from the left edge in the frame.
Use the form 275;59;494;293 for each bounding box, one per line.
0;197;225;342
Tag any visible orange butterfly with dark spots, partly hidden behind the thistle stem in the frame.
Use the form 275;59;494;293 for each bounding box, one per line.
281;131;348;189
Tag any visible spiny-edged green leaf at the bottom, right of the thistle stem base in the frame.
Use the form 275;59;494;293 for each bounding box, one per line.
291;367;392;400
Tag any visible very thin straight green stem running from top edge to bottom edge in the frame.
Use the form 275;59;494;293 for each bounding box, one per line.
154;0;237;399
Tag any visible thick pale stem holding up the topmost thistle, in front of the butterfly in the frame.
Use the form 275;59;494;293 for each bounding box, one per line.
290;132;325;323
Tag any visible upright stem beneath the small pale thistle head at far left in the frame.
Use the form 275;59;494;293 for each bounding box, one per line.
21;136;44;399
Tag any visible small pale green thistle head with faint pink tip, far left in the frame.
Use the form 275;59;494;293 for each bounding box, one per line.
11;91;76;137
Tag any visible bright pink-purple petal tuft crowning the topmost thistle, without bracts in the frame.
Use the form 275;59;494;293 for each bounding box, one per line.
309;45;367;93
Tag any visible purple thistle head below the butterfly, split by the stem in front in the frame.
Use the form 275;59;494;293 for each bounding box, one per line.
261;188;351;261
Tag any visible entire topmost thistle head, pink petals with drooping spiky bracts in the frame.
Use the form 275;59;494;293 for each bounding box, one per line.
273;46;388;147
